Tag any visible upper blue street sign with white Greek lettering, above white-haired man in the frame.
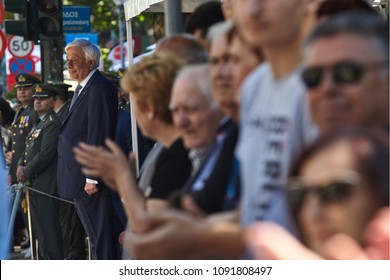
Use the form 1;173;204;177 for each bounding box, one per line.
62;6;91;33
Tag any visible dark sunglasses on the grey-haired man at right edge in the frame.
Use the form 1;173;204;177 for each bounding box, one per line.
302;61;388;89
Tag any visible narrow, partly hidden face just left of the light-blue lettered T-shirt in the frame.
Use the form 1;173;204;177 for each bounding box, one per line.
210;34;237;115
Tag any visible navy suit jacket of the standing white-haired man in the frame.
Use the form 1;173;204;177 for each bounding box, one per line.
57;70;118;199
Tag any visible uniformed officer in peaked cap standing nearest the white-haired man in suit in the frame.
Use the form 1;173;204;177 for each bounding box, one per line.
16;84;64;260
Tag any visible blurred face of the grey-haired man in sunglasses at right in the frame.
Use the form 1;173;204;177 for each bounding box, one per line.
305;34;389;133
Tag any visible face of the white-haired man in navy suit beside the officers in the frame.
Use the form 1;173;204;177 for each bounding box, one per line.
66;47;94;83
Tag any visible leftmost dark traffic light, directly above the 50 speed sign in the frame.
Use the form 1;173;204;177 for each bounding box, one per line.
4;0;38;41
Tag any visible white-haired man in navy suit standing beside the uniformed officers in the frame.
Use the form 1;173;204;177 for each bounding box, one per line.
57;39;119;259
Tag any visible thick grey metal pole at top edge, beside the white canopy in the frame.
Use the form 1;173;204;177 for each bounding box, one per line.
164;0;183;36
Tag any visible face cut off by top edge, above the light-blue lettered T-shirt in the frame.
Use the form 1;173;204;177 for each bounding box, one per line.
232;0;303;47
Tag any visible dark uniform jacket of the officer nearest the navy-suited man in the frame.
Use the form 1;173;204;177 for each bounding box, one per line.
19;110;61;195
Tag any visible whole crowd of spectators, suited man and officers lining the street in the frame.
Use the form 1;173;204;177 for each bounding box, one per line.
0;0;390;259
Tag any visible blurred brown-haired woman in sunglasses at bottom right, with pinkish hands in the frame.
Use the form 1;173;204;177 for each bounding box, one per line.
247;129;389;259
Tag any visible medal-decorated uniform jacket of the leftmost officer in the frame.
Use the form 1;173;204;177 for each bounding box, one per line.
9;103;38;183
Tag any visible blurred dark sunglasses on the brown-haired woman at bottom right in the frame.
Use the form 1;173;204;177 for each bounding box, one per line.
287;171;360;214
